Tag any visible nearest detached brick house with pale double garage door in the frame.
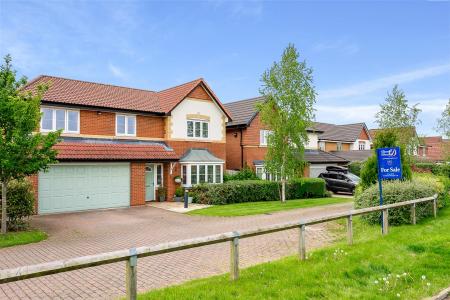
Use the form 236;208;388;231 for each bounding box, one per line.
24;76;231;214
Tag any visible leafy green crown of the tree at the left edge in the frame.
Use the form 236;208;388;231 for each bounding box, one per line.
0;56;60;181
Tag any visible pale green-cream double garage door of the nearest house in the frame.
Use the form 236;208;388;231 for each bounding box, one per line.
38;163;130;214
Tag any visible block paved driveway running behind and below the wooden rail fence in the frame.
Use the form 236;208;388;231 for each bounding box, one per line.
0;203;352;299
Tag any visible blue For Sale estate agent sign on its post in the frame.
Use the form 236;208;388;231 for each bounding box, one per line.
377;147;402;230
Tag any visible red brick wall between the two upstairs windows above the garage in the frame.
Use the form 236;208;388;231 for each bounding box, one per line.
80;110;116;136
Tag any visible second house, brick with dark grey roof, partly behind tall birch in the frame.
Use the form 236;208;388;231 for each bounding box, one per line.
224;97;349;179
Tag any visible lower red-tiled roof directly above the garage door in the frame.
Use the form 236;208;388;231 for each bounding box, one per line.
53;141;179;160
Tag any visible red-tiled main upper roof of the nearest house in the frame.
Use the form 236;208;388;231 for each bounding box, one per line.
24;75;231;119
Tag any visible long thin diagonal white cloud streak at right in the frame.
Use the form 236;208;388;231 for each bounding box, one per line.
318;63;450;99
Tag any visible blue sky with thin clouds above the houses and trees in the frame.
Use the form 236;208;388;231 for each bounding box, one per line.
0;0;450;135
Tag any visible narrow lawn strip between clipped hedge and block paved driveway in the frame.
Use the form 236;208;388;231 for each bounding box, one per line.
188;198;353;217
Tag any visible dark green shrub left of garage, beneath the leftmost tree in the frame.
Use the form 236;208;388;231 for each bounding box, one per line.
0;179;34;230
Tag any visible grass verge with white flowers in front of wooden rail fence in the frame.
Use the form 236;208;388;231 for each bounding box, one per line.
140;207;450;299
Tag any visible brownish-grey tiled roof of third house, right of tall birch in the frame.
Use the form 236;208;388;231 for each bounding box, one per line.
314;122;366;142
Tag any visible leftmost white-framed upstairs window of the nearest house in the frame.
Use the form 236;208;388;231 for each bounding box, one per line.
41;108;80;133
